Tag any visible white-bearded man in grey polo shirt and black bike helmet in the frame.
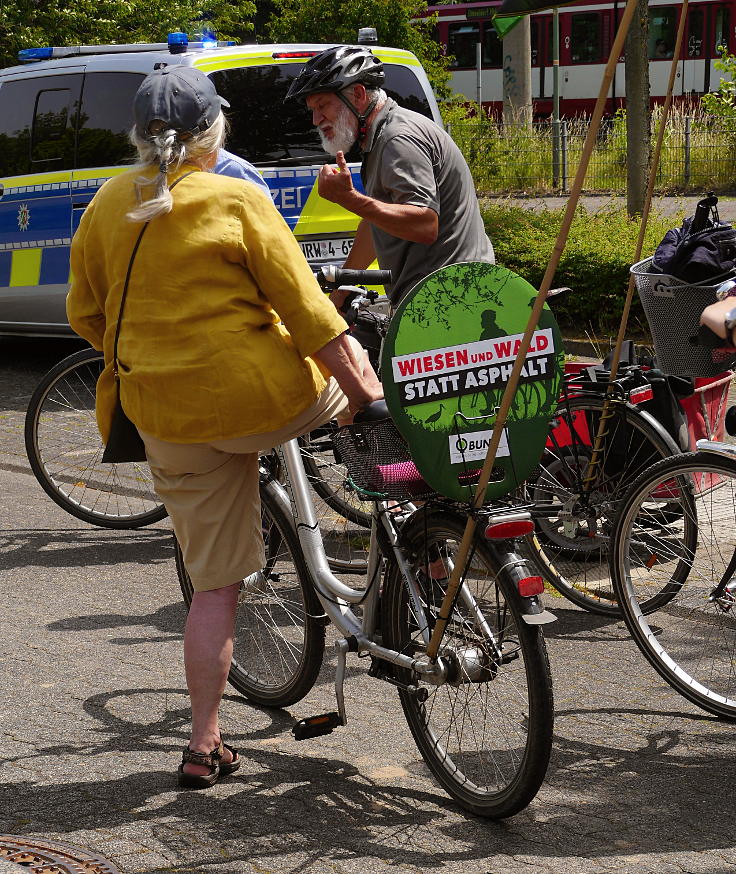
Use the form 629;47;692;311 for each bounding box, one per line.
286;46;495;305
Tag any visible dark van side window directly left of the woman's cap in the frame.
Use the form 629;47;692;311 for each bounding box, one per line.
76;73;144;168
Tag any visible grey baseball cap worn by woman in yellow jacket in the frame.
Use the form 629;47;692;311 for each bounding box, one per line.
133;65;230;137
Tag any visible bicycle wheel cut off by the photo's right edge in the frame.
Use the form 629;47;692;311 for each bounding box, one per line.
611;452;736;719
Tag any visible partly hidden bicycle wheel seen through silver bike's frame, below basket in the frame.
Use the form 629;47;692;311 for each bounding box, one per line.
299;422;371;574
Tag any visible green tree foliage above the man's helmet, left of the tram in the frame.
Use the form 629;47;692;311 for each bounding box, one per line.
268;0;450;97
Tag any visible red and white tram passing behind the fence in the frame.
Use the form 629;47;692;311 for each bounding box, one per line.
428;0;736;117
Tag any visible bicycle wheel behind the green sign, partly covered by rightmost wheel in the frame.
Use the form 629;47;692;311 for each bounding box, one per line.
523;396;679;616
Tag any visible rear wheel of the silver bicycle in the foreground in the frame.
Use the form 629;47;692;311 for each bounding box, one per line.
382;511;554;819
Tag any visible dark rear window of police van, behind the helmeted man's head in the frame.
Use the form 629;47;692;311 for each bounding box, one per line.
212;64;431;166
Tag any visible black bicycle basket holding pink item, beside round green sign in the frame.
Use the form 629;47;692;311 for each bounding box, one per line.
332;419;436;501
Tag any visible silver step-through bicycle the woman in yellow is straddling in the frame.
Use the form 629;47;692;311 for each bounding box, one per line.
176;408;553;819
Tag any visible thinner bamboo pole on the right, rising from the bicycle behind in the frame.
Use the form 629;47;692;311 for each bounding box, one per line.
583;0;688;488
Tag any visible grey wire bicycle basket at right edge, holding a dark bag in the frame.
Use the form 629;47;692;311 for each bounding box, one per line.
631;252;736;377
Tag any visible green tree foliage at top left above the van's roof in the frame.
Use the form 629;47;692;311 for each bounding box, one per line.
0;0;256;67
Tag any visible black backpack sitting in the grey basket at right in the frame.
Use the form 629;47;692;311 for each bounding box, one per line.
650;193;736;285
